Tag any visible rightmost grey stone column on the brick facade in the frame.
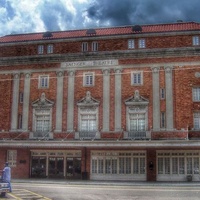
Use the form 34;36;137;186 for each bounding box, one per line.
165;67;174;130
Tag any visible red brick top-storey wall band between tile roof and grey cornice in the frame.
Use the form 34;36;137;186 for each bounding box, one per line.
0;35;192;57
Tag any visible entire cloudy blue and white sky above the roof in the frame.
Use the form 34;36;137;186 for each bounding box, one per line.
0;0;200;36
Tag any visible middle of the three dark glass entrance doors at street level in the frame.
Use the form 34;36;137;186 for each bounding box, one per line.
49;157;64;178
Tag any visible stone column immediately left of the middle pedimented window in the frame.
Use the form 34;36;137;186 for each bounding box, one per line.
67;71;75;132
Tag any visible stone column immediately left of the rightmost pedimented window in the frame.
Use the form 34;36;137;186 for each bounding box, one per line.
115;69;122;131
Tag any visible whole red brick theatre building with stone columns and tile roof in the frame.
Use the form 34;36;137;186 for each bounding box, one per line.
0;22;200;181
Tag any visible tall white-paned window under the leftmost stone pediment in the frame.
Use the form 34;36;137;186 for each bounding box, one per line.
35;109;51;132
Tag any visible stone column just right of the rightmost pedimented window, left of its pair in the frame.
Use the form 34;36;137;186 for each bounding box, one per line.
152;67;160;130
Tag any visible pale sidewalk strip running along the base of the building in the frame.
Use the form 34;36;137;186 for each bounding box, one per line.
12;178;200;187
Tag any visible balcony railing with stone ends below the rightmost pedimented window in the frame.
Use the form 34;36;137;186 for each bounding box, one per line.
124;131;151;140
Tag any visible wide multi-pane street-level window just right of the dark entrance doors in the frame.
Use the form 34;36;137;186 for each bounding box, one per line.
91;152;146;176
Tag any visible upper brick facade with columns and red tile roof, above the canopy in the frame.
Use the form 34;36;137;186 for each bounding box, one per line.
0;22;200;139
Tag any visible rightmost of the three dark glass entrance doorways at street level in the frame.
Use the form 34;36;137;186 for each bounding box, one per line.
66;158;81;179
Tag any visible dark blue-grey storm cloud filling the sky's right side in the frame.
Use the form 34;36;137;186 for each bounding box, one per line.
87;0;200;26
